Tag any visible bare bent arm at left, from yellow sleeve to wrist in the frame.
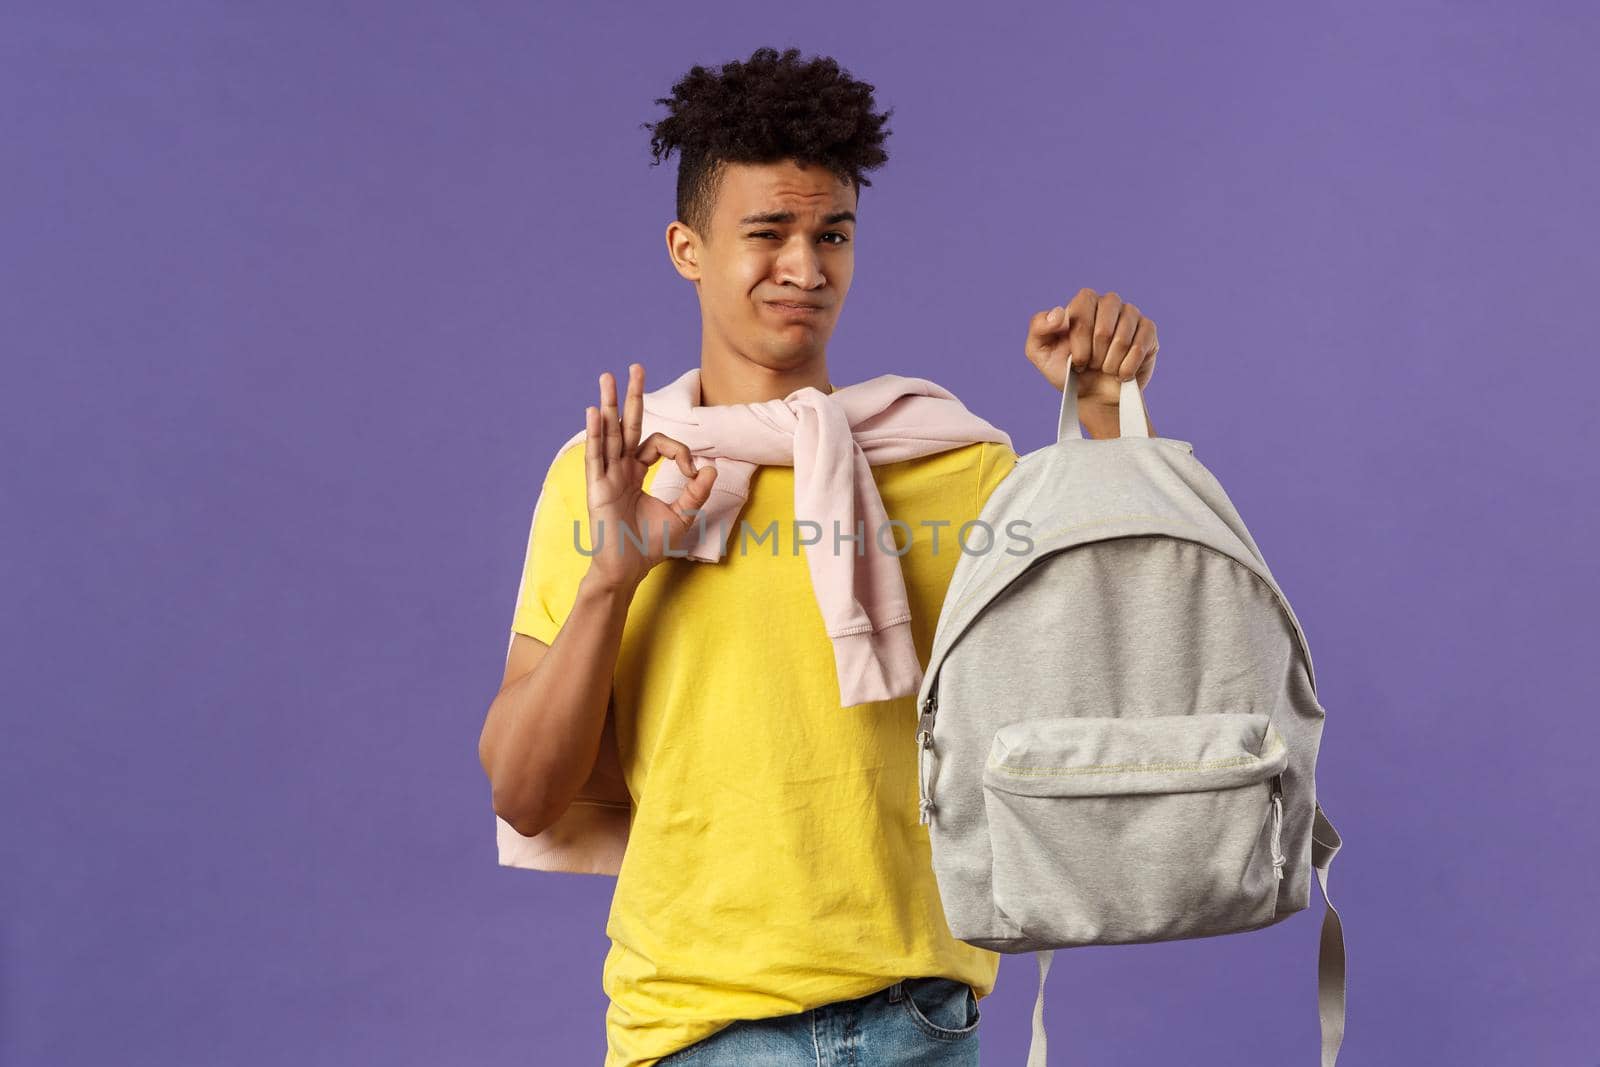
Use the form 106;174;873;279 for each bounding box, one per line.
485;571;635;837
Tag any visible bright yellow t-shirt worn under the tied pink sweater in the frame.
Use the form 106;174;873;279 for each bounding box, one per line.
512;442;1016;1067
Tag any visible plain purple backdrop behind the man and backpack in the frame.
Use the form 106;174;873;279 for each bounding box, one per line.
0;0;1600;1067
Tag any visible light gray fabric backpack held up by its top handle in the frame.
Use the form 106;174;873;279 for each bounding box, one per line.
915;370;1344;1067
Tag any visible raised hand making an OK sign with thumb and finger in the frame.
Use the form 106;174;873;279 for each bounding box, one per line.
584;363;717;587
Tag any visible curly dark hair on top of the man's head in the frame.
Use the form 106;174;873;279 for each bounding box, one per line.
642;48;894;237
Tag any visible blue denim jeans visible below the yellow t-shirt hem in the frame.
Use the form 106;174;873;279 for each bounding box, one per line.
656;977;981;1067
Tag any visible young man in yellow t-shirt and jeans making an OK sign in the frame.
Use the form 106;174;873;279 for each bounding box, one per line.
480;48;1157;1067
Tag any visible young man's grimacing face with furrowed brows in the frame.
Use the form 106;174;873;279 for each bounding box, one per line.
669;160;856;370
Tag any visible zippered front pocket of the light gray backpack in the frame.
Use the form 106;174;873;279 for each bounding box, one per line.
982;713;1288;945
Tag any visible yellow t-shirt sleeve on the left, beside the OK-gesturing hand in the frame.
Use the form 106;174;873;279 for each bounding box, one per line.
510;445;592;645
